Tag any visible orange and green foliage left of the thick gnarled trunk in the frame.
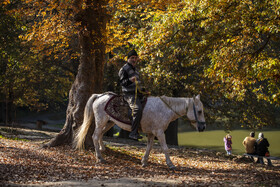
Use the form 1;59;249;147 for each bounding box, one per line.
0;1;75;110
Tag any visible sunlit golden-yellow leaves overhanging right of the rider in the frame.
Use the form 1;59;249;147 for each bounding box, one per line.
122;0;279;104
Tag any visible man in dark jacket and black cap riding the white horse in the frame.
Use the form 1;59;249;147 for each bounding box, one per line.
119;50;143;140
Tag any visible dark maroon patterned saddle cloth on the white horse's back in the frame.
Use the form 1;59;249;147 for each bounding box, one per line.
104;95;147;125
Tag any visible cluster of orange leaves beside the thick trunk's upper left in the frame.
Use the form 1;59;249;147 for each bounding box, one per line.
18;0;75;58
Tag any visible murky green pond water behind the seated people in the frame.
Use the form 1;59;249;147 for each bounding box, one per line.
178;129;280;157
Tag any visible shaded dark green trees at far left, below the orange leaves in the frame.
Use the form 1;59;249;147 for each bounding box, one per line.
0;1;73;123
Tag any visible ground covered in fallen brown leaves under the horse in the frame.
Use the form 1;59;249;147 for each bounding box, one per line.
0;127;280;186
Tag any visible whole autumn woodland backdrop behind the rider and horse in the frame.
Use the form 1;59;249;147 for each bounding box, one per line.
0;0;280;146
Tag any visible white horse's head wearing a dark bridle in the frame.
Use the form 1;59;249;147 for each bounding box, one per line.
187;95;206;132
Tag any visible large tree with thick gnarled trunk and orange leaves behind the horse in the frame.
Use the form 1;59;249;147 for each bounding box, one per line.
4;0;109;146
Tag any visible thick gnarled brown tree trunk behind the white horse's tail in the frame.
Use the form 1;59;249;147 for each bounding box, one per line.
44;0;107;148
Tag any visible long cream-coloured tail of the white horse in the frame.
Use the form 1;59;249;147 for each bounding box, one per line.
74;94;99;150
